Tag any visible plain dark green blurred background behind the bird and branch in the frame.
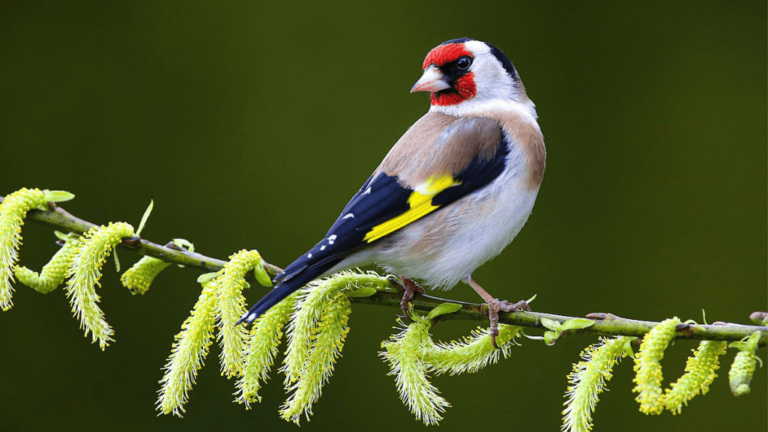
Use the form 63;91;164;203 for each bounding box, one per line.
0;0;768;431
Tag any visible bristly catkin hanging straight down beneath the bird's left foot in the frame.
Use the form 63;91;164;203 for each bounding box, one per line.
380;316;451;425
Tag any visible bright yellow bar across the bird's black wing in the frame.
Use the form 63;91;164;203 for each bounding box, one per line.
363;175;461;243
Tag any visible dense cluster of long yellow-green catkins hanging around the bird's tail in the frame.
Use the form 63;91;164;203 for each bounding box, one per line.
157;268;389;423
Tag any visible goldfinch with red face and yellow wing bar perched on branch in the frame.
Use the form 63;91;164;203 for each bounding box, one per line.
240;38;546;346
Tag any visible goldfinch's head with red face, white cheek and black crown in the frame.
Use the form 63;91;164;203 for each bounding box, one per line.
411;38;536;117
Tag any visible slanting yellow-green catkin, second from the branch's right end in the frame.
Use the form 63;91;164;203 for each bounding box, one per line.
664;341;728;414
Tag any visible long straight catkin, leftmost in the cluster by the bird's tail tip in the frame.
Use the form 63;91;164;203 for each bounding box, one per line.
157;282;216;417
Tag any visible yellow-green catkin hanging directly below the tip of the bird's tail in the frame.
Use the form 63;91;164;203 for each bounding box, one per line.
236;293;296;408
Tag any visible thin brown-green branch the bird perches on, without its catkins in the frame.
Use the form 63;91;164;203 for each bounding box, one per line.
0;197;768;346
